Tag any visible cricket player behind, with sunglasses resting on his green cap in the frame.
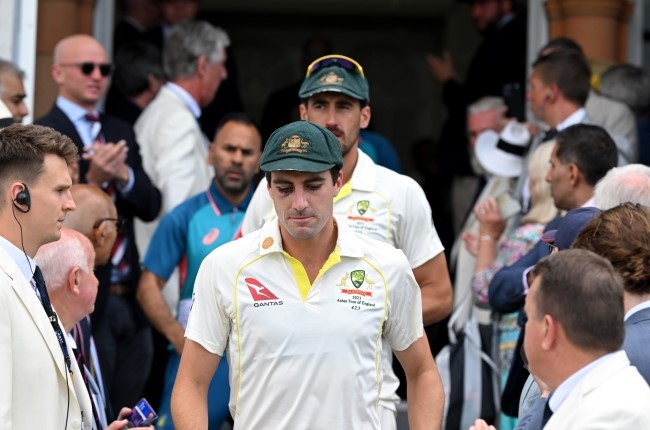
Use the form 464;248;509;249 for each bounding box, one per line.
242;55;452;429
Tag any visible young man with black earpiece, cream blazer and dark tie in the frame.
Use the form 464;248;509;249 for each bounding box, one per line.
0;124;92;430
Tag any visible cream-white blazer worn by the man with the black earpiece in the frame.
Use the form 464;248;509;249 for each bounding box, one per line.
0;248;92;430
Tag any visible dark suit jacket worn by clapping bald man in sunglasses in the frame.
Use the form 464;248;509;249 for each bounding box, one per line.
35;105;162;320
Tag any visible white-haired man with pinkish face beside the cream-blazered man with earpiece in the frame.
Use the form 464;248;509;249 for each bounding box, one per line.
34;228;152;430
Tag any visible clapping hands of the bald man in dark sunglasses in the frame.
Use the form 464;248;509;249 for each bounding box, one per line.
82;139;129;187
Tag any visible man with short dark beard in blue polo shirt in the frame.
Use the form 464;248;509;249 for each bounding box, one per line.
137;114;262;429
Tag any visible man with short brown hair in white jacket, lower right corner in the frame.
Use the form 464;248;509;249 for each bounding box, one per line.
475;249;650;430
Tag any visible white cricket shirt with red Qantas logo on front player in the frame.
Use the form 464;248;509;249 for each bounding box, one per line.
186;220;423;430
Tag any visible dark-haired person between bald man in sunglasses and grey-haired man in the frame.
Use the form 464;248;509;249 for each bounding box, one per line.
106;42;165;126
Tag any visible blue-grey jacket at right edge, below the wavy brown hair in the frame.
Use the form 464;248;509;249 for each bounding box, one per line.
623;308;650;384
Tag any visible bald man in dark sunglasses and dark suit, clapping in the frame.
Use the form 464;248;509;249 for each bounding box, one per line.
36;34;161;416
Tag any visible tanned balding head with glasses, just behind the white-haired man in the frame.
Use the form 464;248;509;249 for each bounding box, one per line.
63;184;118;266
